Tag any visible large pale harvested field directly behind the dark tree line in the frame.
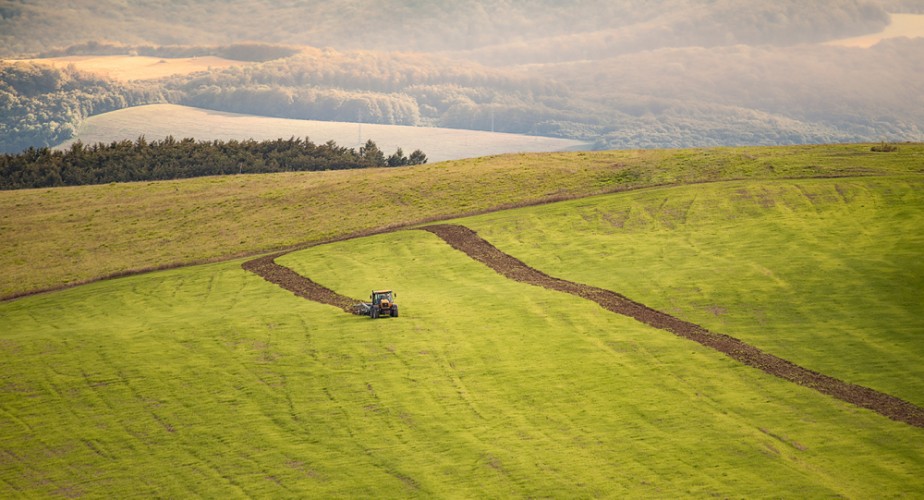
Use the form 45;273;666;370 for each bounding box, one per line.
60;104;589;162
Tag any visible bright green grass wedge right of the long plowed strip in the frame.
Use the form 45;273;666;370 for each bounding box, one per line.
462;176;924;405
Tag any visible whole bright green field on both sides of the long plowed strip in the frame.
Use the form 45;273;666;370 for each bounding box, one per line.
0;171;924;498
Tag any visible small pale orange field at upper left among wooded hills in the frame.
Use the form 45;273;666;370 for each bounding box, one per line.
9;55;249;81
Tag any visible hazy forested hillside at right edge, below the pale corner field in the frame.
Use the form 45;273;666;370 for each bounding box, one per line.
532;38;924;147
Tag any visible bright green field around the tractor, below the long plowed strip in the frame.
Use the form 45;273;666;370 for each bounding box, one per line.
0;231;924;497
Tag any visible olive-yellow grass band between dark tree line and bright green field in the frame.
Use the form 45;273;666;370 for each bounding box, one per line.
0;144;924;297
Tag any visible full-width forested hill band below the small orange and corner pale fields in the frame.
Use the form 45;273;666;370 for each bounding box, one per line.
9;35;924;153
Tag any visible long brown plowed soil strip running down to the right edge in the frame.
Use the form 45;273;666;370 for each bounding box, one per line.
422;224;924;427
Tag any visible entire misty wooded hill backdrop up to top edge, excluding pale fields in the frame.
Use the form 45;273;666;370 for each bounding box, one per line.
0;0;924;151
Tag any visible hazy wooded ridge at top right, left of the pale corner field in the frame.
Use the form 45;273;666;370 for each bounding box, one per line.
456;0;889;66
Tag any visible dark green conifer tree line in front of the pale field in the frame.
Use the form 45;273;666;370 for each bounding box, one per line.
0;136;427;189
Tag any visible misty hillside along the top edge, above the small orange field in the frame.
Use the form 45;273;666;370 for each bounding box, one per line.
0;0;924;59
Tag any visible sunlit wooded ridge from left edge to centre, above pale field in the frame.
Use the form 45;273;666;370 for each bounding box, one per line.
0;54;600;153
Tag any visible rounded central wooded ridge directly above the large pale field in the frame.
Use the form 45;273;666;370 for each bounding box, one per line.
165;48;593;137
